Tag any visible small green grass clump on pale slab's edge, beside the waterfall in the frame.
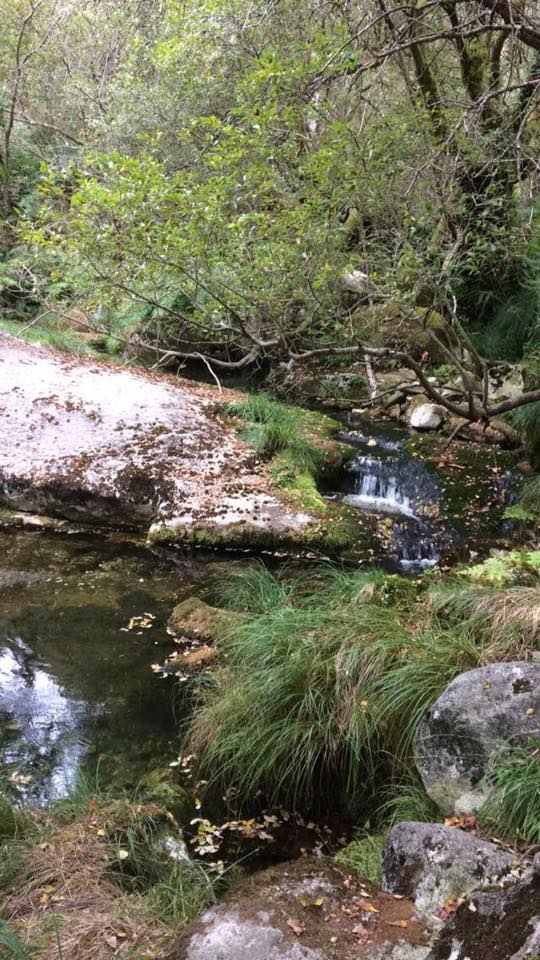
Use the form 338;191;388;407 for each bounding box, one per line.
225;393;330;475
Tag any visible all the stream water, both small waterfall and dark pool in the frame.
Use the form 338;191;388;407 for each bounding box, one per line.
0;421;516;803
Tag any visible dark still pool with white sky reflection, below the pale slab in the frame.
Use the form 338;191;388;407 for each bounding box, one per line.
0;531;200;802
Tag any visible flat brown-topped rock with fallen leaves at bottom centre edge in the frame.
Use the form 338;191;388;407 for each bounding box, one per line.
161;859;427;960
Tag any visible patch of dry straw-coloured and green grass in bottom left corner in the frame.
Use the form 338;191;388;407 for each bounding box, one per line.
0;780;225;960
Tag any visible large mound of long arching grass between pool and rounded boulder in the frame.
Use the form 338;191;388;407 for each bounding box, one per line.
188;555;540;816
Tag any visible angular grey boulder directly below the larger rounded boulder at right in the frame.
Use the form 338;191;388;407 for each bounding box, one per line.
382;821;514;917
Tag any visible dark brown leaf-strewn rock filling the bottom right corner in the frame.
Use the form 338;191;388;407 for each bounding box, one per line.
427;857;540;960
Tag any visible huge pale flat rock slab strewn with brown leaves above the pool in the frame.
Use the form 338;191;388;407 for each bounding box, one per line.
0;334;322;546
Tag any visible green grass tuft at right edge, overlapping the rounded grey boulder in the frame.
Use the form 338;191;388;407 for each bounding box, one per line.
480;741;540;844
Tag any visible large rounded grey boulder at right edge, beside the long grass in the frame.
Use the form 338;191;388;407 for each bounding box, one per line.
414;662;540;814
